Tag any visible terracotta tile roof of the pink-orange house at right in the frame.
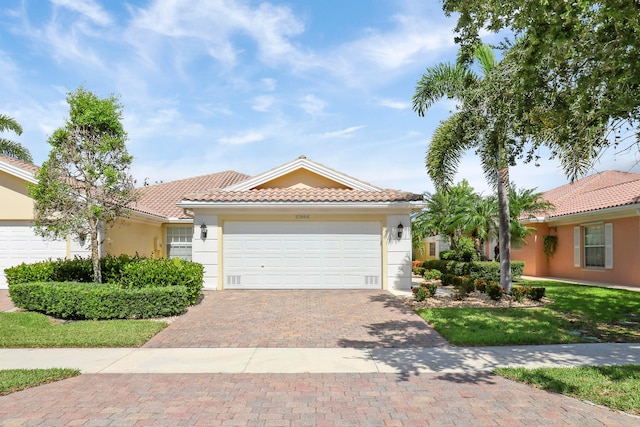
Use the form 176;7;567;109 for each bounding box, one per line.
543;170;640;218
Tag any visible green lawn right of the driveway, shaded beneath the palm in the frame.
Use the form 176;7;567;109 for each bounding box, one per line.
417;281;640;346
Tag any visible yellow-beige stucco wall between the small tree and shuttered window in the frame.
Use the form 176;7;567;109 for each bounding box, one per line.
104;219;166;257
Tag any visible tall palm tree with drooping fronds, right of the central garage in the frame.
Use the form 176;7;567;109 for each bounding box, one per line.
413;44;513;292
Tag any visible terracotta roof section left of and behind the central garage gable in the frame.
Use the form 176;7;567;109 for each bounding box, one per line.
134;171;250;218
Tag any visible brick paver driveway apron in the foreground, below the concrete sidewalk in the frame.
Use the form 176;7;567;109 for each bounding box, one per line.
0;374;640;427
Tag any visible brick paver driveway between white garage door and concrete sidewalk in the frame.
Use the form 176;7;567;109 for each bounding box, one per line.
145;290;447;348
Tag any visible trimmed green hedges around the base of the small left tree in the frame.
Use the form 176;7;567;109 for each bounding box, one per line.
5;255;204;319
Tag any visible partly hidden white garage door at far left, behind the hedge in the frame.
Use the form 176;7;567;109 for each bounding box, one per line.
0;222;67;288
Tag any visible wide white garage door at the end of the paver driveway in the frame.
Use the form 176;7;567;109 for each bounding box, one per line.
223;221;382;289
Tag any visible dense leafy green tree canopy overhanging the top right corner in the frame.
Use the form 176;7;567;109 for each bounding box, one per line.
442;0;640;181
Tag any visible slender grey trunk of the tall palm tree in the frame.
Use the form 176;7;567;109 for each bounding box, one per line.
498;167;511;292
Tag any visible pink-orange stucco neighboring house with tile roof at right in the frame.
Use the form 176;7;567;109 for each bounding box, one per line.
511;171;640;287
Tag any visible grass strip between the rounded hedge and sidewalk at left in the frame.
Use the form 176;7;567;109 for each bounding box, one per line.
0;312;167;348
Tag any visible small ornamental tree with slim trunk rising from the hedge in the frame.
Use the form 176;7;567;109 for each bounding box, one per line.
29;87;137;283
